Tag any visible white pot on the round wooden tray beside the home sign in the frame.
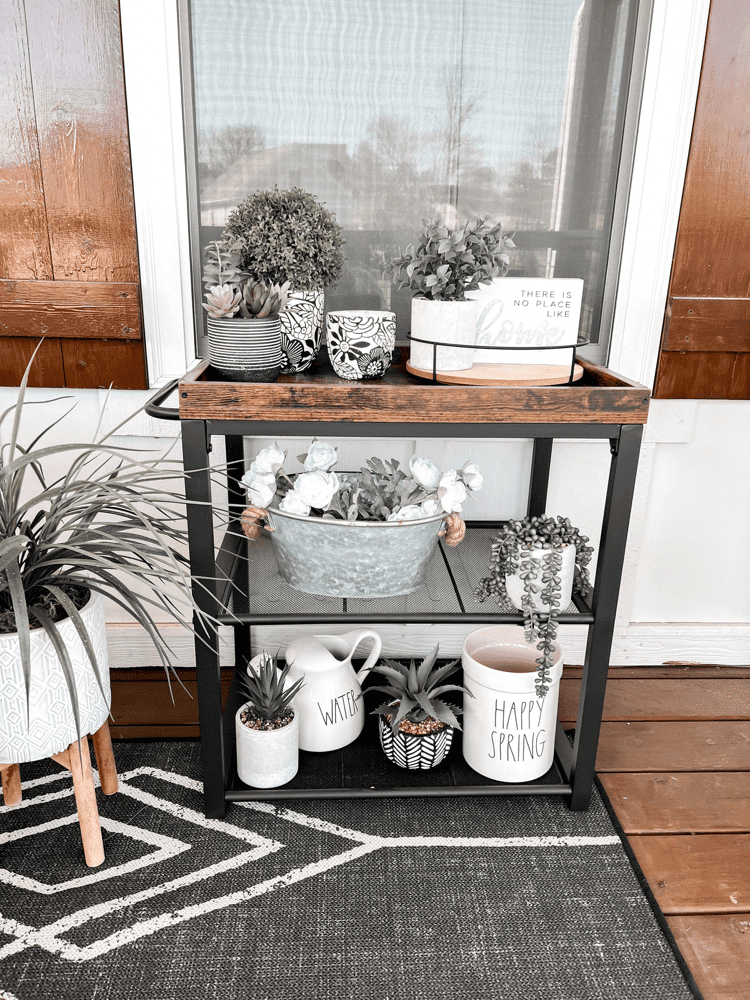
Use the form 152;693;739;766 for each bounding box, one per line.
410;297;480;372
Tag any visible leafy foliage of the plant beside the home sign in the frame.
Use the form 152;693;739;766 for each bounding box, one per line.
379;215;516;302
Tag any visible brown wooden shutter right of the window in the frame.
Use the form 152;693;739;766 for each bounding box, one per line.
654;0;750;400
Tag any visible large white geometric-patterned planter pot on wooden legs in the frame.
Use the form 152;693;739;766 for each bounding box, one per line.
0;593;111;764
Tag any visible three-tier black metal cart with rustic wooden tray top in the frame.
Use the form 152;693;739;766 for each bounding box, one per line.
146;350;650;818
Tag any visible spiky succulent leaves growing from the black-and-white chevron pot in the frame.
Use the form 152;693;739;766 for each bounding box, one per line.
367;644;472;733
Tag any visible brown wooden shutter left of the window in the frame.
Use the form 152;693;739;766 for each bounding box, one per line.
0;0;148;389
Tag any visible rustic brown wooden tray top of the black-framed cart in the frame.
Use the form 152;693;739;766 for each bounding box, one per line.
178;348;651;425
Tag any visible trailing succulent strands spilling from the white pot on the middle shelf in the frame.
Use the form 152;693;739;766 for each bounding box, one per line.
474;515;594;698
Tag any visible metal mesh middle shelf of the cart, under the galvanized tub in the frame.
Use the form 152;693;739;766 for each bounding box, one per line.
216;521;594;625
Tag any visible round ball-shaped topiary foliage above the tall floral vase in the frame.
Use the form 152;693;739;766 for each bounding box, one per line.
221;187;343;292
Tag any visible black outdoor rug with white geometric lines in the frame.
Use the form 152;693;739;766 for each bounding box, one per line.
0;741;696;1000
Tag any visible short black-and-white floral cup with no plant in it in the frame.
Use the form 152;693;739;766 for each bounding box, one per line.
326;310;396;379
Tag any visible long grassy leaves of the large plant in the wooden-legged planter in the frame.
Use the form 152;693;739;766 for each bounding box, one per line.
0;349;215;739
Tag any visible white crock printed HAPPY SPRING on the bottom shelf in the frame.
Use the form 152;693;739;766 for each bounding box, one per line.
461;625;563;783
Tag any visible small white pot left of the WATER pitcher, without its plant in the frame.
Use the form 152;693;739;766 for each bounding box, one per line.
234;702;299;790
